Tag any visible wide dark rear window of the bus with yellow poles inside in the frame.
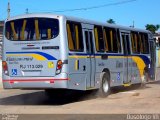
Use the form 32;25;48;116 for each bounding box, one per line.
5;18;59;41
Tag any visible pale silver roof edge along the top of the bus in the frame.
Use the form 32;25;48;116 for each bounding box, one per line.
5;13;151;33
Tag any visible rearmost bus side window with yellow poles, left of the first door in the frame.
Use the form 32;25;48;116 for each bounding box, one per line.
67;21;84;52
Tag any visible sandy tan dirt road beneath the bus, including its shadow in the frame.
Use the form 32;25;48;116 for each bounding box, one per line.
0;81;160;114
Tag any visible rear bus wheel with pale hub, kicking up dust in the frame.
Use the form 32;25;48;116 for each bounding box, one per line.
98;72;111;97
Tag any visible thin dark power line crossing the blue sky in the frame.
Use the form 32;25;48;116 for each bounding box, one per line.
53;0;137;12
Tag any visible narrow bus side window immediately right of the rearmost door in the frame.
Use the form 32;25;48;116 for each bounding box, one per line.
94;26;105;52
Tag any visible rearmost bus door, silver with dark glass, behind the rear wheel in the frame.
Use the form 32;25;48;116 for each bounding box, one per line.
84;29;95;89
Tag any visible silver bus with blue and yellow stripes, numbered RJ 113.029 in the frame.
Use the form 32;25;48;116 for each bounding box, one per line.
2;14;155;96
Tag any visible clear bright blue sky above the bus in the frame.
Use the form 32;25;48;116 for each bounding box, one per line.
0;0;160;29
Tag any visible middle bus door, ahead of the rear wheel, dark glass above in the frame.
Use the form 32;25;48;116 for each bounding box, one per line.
121;32;132;84
